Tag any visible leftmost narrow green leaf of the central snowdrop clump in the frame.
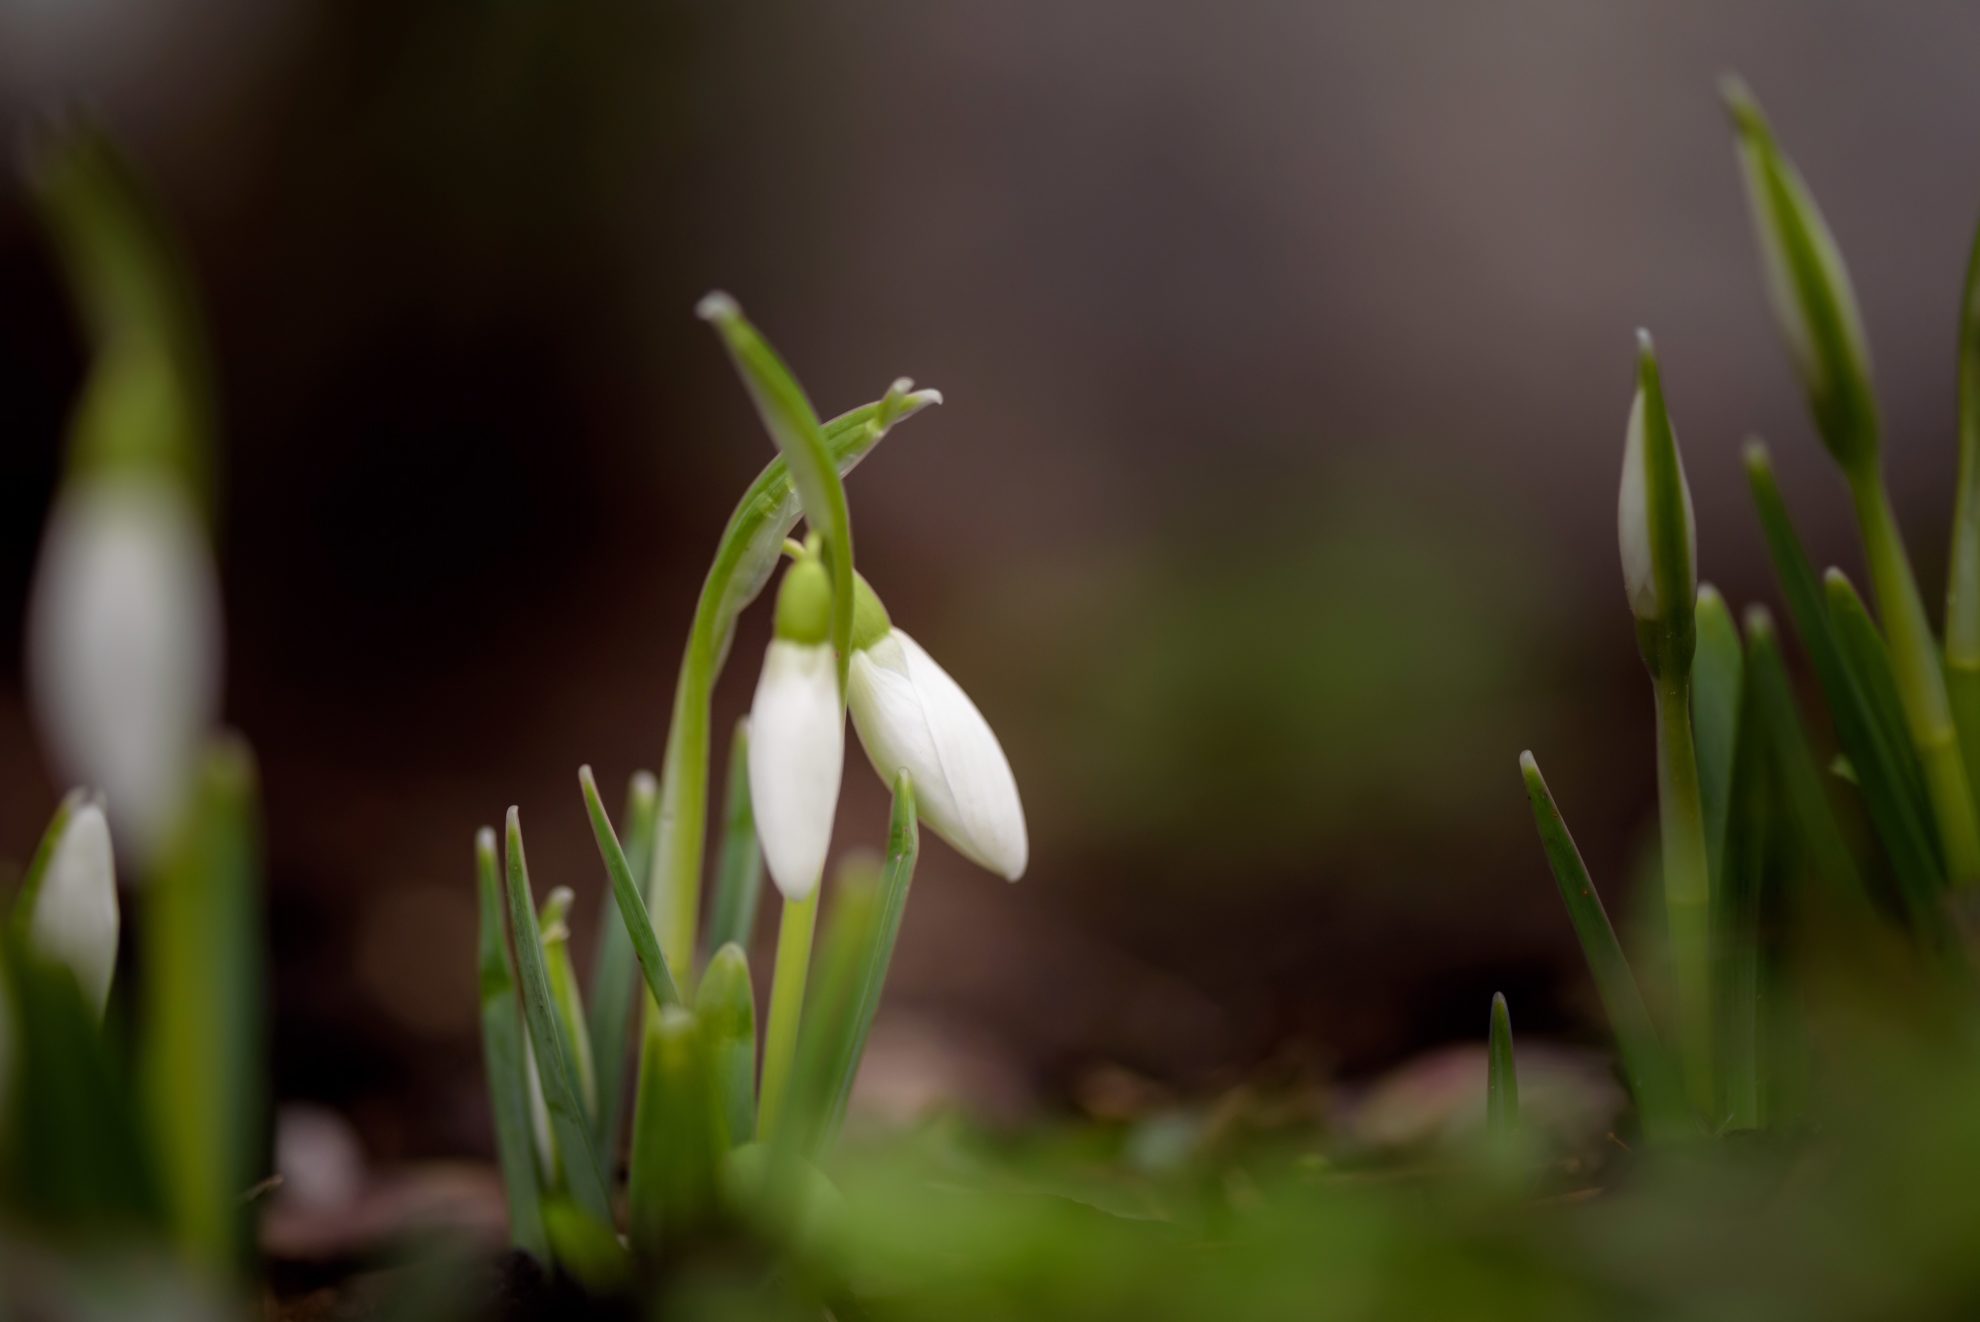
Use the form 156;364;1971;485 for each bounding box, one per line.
475;827;550;1263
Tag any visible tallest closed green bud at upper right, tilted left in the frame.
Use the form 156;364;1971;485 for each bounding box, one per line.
1721;79;1877;475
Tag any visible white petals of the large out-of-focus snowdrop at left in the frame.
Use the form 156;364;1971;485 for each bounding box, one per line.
28;477;220;861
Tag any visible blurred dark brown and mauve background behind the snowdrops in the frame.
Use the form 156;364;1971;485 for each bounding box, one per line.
0;0;1980;1160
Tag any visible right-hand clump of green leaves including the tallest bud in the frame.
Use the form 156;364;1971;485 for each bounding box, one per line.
1523;81;1980;1142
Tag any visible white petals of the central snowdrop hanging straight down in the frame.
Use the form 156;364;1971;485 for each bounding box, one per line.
748;639;845;900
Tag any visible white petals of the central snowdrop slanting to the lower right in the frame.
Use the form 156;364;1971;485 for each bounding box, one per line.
847;627;1030;881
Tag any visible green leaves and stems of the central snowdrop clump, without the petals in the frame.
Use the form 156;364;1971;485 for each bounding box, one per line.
475;304;937;1290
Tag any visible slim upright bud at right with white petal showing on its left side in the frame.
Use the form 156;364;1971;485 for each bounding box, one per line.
1616;331;1699;659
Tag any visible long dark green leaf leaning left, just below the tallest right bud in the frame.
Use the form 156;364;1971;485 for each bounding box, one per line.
1746;445;1946;893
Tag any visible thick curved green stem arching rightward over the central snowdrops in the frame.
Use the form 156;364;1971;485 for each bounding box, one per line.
647;380;942;980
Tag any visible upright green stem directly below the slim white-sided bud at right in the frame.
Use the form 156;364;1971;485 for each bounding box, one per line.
1655;675;1713;1110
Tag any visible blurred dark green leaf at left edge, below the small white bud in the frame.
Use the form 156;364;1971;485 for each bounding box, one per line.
0;928;164;1239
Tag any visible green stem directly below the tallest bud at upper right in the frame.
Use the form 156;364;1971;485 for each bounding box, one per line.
1849;469;1980;887
